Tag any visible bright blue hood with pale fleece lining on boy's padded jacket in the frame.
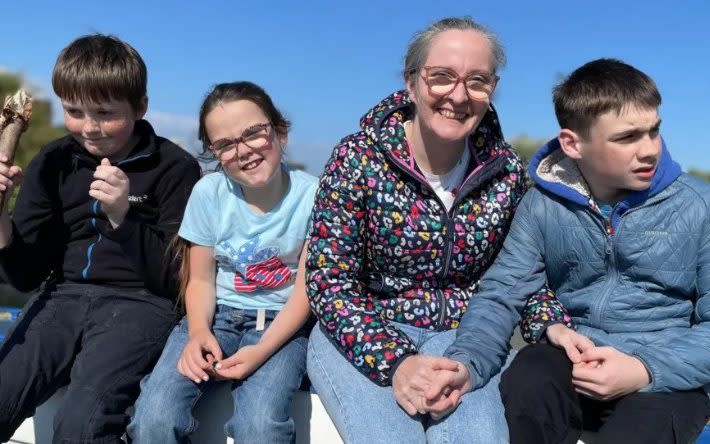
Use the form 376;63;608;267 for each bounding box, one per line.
528;138;681;208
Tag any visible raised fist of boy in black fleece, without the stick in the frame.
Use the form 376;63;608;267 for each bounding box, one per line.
89;158;130;228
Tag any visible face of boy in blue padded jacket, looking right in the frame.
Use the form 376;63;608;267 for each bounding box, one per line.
560;106;661;203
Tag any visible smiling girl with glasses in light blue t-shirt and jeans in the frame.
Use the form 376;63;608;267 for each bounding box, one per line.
128;82;317;443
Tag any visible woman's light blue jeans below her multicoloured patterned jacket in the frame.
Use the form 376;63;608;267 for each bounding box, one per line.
308;323;511;444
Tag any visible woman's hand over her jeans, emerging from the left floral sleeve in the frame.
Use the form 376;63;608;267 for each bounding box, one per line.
392;355;458;416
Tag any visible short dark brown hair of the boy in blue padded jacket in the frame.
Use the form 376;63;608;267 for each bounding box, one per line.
552;59;661;139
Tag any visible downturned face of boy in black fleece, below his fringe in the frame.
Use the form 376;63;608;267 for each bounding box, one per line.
62;97;147;163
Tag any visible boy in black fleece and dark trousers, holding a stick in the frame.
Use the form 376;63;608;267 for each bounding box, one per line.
0;35;200;443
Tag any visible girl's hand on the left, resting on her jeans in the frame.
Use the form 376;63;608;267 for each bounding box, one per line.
177;330;222;384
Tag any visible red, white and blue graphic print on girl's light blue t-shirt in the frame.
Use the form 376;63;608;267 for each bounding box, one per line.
216;236;291;292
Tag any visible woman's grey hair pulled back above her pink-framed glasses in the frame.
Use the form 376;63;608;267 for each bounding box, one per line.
403;16;505;81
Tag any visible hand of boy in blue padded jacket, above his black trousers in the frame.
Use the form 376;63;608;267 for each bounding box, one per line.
572;347;651;401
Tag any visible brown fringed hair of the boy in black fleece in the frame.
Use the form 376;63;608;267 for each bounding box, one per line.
52;34;148;110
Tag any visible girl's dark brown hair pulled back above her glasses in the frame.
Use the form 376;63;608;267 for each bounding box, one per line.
197;81;291;158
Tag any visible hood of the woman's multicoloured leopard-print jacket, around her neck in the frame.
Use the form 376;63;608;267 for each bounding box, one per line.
360;90;509;161
